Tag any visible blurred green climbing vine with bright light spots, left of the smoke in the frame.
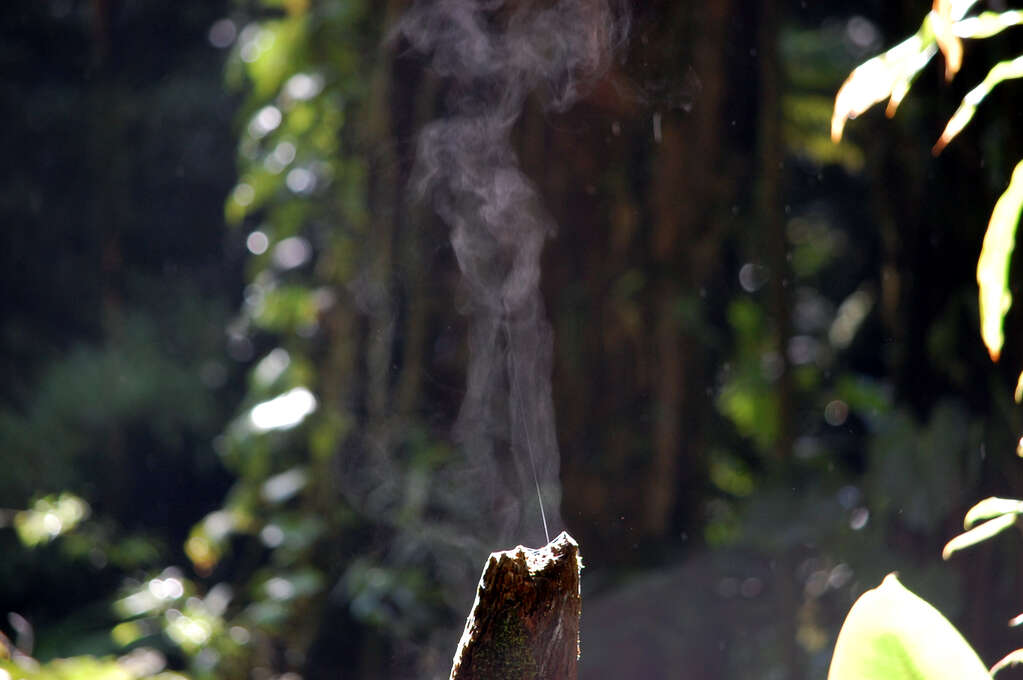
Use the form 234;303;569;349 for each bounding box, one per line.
142;0;462;678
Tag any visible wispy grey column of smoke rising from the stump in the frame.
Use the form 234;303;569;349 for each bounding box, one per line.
398;0;627;548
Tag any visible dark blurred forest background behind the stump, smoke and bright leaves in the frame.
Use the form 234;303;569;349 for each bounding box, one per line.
0;0;1023;679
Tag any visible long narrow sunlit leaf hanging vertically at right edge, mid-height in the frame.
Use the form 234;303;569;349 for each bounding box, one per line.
977;160;1023;361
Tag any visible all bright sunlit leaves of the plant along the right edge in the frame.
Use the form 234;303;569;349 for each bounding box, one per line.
829;0;1023;680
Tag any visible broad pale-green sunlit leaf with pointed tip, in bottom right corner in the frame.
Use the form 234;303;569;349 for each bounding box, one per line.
828;574;991;680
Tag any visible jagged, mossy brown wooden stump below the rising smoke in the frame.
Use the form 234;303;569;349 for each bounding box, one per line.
451;532;582;680
